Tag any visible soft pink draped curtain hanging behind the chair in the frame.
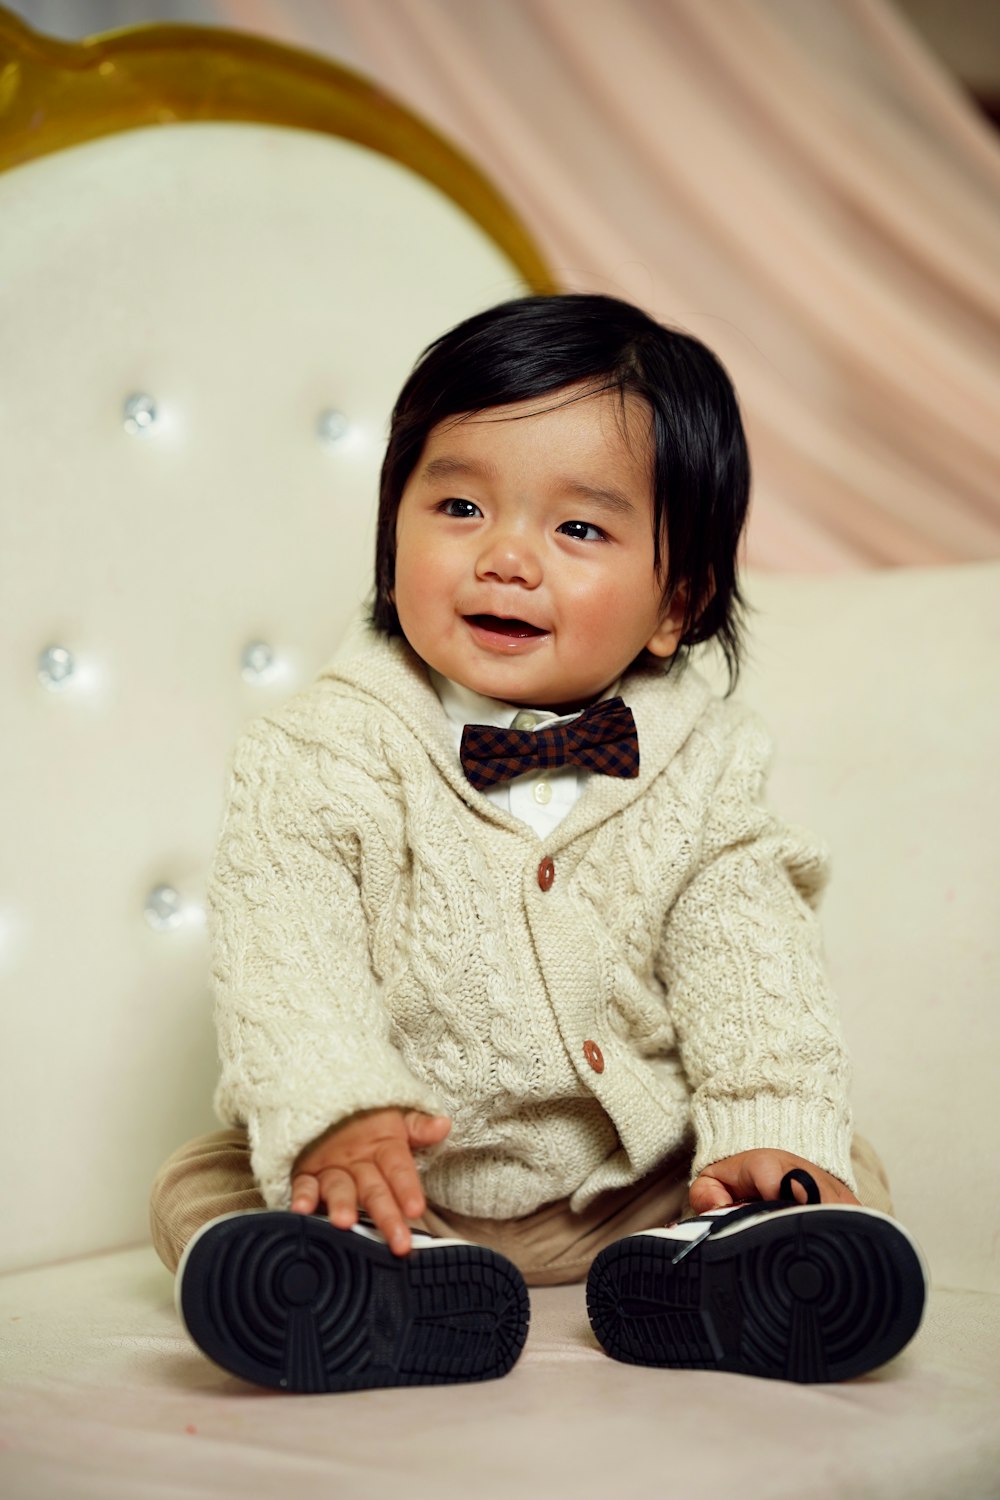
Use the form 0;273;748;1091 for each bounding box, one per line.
223;0;1000;572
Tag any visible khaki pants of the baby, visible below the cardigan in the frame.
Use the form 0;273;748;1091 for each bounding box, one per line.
150;1128;892;1287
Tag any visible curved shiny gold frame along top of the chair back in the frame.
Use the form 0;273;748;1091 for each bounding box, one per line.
0;6;558;293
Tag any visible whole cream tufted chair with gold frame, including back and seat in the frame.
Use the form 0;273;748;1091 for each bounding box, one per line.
0;9;1000;1500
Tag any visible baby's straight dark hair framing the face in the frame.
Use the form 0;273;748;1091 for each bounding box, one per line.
372;293;750;689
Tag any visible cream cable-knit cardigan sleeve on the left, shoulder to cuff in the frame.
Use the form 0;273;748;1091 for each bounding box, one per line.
208;720;439;1208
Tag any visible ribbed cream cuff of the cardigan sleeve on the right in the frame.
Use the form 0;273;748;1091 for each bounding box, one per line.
691;1095;858;1193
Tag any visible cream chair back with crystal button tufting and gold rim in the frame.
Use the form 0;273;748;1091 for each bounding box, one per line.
0;15;544;1269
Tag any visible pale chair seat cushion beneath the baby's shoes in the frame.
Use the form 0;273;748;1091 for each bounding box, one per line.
0;1247;1000;1500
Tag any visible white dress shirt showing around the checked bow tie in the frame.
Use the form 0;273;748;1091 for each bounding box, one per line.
429;668;619;839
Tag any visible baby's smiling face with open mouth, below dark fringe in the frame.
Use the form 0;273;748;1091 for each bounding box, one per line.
393;387;681;711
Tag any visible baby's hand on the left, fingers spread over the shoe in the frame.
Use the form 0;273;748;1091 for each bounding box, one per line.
292;1110;451;1256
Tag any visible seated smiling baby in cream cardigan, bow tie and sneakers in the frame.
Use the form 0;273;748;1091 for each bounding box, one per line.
151;296;925;1391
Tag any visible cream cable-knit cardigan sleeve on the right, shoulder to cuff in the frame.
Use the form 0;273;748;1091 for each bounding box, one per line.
658;711;856;1191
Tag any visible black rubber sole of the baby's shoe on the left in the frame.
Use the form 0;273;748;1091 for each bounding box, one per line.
178;1211;529;1392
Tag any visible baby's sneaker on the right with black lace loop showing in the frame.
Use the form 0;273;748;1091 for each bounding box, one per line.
586;1167;930;1383
